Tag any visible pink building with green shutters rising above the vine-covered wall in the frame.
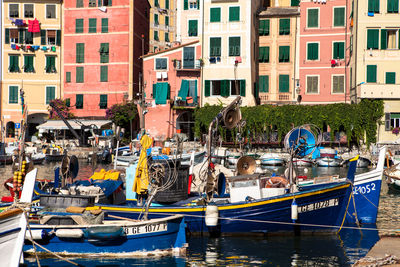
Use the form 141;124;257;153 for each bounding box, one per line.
297;0;351;104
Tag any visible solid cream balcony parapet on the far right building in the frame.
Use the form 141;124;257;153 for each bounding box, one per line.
357;83;400;99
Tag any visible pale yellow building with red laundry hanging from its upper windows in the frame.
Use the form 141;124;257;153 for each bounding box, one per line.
1;0;62;141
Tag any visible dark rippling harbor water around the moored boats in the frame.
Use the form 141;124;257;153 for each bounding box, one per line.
0;162;400;267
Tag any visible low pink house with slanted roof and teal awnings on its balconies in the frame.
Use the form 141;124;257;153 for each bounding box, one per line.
143;40;201;141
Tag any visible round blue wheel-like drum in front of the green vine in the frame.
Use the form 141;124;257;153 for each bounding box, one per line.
284;124;321;158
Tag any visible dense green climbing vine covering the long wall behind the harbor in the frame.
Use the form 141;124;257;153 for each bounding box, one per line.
195;99;384;148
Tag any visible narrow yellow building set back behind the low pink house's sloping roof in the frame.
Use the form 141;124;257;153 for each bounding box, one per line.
149;0;175;52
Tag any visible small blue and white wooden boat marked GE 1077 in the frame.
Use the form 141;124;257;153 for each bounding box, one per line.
24;215;187;257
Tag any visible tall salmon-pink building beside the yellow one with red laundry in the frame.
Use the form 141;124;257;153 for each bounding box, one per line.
63;0;150;117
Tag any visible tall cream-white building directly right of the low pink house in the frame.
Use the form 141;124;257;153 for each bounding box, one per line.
200;0;264;106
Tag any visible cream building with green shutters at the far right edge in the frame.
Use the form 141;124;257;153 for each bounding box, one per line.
349;0;400;143
